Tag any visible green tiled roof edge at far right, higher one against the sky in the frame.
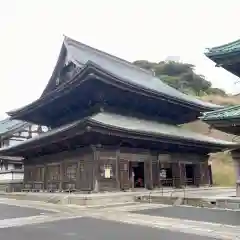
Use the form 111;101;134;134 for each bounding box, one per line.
205;39;240;58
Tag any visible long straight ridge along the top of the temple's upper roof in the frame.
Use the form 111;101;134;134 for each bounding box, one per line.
64;36;153;76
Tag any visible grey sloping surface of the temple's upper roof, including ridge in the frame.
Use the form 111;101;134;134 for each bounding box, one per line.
61;37;221;109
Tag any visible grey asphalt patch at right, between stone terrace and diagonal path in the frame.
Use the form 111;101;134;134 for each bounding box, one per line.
134;206;240;226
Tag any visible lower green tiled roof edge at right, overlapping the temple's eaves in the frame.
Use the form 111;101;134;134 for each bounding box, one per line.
201;105;240;121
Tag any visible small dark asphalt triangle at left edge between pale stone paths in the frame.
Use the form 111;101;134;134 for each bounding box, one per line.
0;204;53;220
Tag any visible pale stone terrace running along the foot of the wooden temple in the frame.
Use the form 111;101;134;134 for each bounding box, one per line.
0;187;235;207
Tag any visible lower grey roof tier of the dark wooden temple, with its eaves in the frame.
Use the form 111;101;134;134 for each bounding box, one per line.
0;112;236;155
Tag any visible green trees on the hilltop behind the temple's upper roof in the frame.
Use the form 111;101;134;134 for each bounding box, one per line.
134;60;226;96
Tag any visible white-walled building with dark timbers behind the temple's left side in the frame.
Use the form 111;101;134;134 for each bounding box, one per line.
0;118;46;191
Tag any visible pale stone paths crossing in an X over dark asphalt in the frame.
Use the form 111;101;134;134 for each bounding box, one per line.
0;199;240;239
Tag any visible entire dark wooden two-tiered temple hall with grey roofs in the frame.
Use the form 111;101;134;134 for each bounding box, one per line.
0;37;239;192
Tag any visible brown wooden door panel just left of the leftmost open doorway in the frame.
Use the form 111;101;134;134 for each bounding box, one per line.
119;159;130;190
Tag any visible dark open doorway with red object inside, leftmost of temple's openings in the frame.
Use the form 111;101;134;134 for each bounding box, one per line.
130;162;145;188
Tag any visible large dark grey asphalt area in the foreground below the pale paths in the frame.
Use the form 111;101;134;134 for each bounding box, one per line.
0;218;218;240
